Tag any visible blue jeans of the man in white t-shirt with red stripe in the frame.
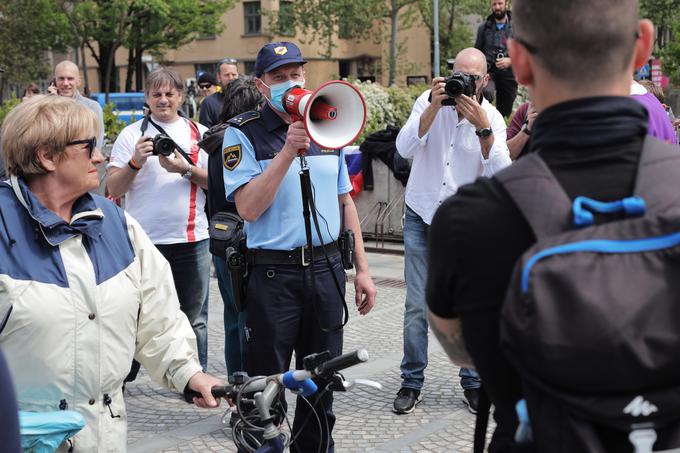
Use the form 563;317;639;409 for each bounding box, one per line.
156;239;210;371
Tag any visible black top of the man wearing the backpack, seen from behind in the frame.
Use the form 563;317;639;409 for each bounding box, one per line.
427;97;647;452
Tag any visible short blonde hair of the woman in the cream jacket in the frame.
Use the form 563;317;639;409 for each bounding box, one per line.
0;95;101;176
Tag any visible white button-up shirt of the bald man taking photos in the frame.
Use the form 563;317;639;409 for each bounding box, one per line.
396;90;512;225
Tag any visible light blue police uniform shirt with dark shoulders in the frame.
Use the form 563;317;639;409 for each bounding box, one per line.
222;105;352;250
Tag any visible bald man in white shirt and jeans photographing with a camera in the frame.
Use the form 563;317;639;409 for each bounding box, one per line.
394;48;511;414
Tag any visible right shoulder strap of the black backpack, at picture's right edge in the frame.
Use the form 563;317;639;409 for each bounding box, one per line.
634;136;680;214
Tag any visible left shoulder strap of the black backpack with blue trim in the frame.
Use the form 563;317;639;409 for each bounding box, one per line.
494;153;571;239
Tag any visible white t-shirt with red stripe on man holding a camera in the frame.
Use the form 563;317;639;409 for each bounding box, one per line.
107;118;208;244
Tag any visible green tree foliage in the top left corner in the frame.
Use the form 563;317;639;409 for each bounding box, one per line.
0;0;72;98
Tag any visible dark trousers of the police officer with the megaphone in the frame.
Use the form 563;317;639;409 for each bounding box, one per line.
244;254;345;453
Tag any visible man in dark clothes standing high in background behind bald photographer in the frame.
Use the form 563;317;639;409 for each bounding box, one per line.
475;0;517;117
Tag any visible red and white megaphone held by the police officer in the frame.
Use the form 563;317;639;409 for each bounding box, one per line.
283;80;366;149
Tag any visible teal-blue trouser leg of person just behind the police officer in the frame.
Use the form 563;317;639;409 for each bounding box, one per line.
213;256;246;376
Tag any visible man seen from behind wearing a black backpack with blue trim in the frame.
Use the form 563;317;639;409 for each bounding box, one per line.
427;0;680;453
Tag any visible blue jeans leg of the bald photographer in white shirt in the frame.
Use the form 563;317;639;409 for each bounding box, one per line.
401;206;429;390
